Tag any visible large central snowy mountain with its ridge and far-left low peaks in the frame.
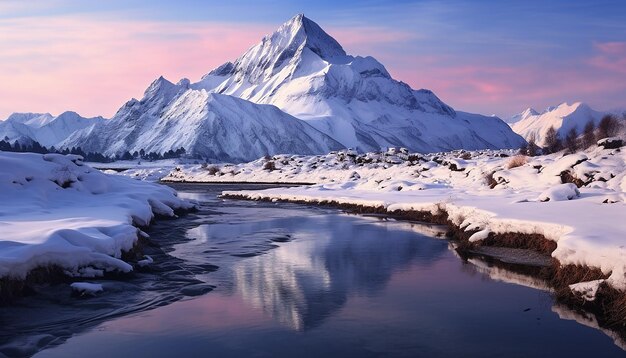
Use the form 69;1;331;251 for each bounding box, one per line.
0;14;525;161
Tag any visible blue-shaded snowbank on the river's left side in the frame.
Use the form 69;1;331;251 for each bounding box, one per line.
0;152;193;280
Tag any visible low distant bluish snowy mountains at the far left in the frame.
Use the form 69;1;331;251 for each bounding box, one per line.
0;111;104;147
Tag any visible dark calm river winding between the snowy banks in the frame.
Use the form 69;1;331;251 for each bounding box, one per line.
0;184;624;357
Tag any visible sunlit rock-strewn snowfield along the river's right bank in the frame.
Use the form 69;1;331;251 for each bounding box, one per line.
163;147;626;289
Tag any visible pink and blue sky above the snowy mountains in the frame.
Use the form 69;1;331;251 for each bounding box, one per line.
0;0;626;117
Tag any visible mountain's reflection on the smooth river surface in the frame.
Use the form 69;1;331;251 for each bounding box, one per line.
227;216;447;330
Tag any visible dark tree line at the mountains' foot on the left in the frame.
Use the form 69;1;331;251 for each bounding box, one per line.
0;137;186;163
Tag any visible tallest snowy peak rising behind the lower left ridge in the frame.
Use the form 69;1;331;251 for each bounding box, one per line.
191;14;524;152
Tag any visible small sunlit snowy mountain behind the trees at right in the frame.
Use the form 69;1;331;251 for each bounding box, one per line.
509;102;606;145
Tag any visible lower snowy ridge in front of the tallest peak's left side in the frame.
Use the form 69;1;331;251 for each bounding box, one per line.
62;77;343;162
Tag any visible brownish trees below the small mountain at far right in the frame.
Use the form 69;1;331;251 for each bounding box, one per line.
520;114;626;157
